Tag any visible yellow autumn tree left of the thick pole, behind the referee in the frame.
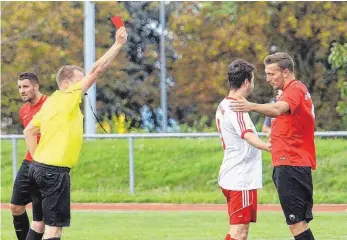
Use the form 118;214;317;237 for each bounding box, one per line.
1;2;83;133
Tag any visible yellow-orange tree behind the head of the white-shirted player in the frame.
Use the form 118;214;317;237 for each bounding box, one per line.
171;2;271;123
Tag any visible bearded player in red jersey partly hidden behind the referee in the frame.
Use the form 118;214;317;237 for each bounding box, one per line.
11;72;47;240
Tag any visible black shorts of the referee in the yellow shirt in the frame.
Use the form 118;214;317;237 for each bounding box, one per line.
29;162;70;227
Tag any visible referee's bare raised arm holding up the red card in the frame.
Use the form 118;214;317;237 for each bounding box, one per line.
82;27;128;94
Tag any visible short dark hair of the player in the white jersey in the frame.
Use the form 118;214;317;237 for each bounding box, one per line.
228;59;256;89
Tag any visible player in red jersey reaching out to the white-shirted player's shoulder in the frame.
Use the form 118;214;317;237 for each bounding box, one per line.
230;52;316;240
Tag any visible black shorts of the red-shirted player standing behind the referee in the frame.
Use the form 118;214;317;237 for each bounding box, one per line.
11;160;43;221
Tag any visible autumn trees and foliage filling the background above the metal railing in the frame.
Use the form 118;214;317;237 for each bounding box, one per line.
1;1;347;133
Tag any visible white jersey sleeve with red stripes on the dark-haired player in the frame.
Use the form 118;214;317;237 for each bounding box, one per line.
230;112;253;139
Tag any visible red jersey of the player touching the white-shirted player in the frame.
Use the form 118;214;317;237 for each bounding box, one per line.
271;80;316;169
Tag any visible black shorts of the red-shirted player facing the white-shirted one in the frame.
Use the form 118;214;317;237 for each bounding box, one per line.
272;166;313;225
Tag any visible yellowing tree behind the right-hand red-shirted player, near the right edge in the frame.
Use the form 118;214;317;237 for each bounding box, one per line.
269;2;347;130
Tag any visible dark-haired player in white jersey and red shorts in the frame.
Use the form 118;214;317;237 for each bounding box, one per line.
216;59;271;240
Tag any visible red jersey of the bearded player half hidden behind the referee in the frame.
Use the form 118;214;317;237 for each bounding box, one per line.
19;95;47;161
